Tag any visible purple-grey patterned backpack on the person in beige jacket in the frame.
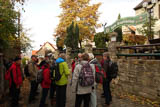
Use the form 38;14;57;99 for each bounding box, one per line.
79;63;94;87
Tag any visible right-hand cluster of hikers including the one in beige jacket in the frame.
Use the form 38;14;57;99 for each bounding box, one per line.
71;52;112;107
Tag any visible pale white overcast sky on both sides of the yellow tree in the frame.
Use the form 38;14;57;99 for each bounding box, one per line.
21;0;142;50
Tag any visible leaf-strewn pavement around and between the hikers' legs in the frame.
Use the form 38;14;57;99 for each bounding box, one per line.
0;80;153;107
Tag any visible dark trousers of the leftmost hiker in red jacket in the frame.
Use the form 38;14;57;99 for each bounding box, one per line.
11;86;20;107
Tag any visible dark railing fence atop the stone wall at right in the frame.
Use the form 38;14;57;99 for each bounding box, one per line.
117;43;160;59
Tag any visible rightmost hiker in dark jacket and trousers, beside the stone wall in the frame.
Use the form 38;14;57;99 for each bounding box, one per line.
103;52;112;107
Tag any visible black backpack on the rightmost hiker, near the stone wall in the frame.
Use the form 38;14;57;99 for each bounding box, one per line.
108;61;118;78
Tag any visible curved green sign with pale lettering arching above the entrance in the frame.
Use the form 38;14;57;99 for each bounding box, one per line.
104;12;148;33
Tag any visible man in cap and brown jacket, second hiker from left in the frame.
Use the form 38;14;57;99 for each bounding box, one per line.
28;55;38;103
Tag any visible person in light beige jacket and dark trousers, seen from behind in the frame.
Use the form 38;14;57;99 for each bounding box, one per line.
72;53;95;107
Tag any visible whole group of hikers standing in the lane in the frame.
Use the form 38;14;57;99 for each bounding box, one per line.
5;52;115;107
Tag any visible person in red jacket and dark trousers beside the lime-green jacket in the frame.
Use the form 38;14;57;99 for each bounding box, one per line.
39;61;51;107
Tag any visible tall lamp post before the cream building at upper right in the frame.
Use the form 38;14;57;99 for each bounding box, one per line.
143;0;158;40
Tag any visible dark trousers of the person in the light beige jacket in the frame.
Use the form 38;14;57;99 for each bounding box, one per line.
75;94;91;107
